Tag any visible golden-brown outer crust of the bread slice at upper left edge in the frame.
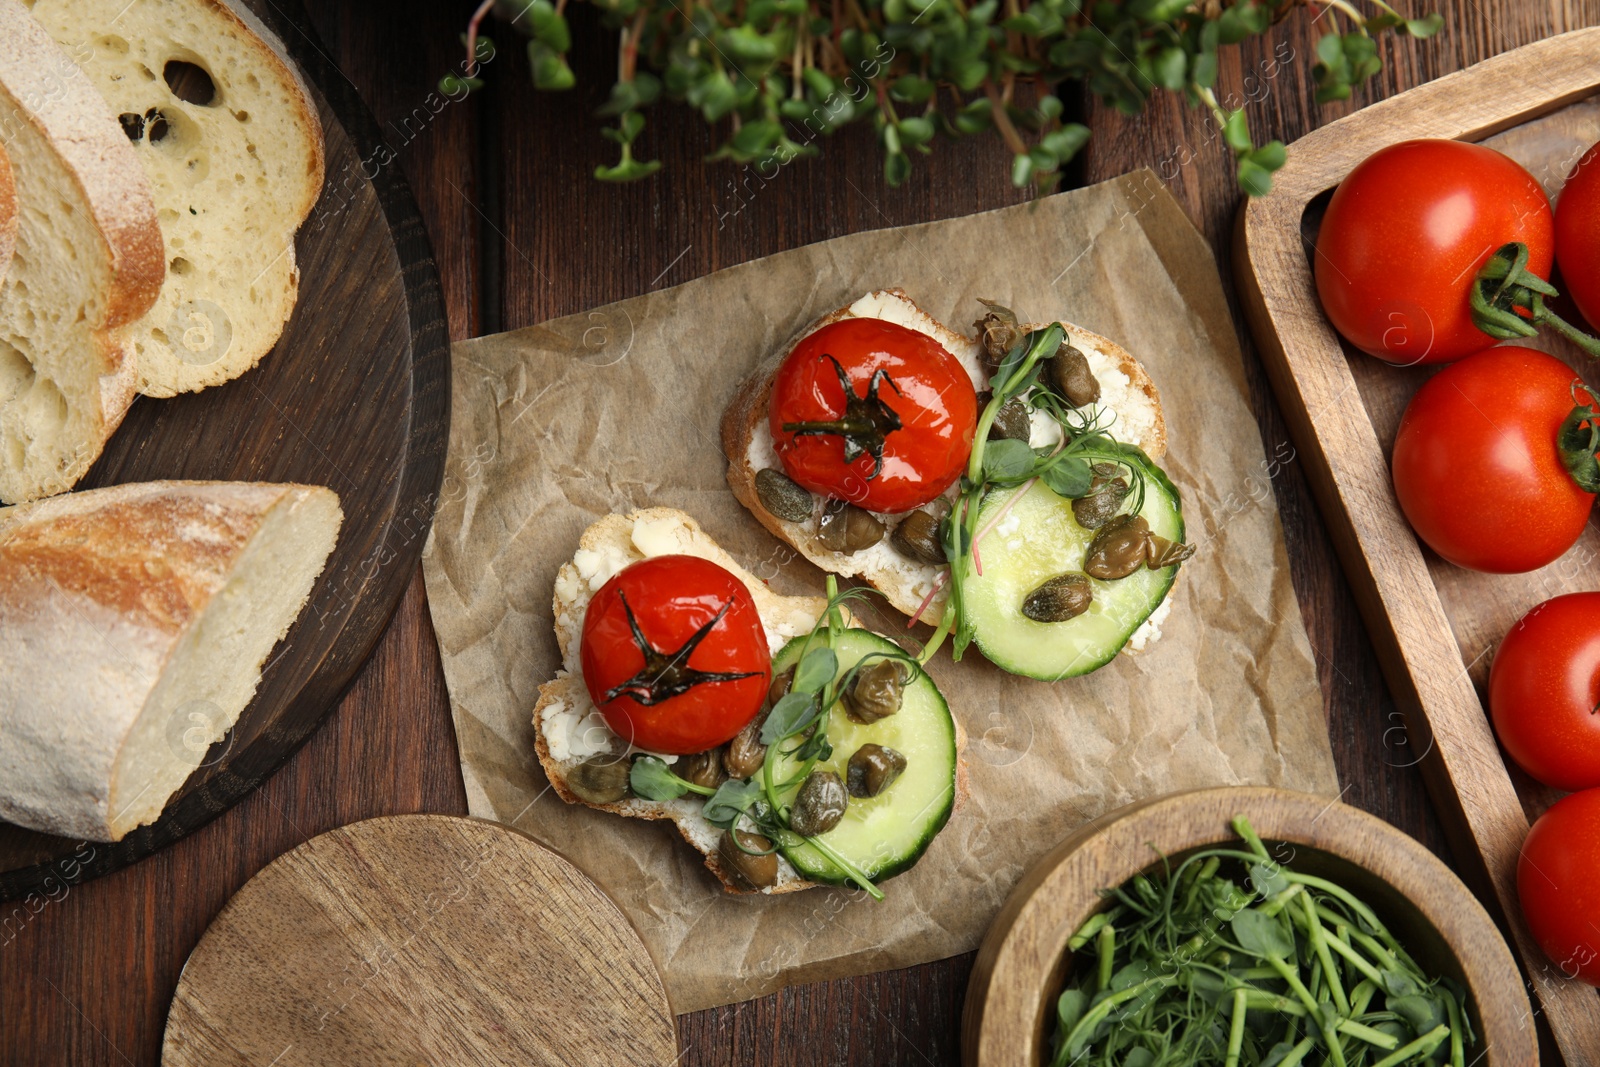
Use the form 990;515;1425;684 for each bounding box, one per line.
0;0;166;329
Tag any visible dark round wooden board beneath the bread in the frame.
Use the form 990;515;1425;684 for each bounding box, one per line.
0;0;450;901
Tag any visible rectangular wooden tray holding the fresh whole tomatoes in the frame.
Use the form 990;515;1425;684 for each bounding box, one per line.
1234;29;1600;1067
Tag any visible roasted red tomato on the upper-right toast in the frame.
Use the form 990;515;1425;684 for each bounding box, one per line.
768;318;978;512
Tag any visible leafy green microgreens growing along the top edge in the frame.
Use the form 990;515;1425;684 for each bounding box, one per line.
440;0;1443;195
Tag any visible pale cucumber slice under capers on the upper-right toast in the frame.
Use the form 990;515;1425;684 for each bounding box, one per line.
962;453;1184;681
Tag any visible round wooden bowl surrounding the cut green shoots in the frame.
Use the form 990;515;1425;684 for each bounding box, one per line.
962;787;1539;1067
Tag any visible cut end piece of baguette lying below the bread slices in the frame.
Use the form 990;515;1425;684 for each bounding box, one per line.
0;482;342;841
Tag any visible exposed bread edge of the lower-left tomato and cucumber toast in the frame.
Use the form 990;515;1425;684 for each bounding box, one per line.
533;507;970;896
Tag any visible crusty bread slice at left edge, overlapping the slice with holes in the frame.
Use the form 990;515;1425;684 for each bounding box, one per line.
0;0;165;502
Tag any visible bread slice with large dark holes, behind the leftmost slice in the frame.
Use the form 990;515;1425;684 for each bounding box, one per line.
32;0;323;397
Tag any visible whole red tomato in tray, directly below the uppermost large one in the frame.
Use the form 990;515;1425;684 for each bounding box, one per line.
1394;346;1595;574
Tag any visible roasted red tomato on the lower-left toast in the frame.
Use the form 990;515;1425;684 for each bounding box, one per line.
579;555;773;755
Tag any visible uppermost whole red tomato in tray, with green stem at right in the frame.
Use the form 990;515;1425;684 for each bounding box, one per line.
1314;141;1555;365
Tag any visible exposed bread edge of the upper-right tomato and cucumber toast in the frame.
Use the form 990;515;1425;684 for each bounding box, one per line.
722;290;1166;627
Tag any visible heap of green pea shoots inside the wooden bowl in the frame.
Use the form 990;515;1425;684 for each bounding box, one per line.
1051;816;1475;1067
